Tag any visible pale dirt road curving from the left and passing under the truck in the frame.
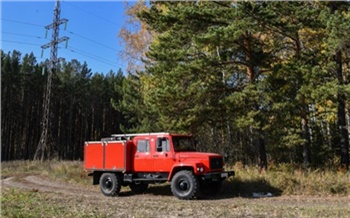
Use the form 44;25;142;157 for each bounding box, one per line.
1;175;350;217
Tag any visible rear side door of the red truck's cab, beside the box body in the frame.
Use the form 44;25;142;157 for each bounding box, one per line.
133;138;153;172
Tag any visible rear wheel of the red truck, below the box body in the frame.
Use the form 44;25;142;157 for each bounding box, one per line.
100;173;122;196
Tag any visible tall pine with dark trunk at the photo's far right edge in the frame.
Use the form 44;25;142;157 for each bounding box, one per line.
323;2;350;170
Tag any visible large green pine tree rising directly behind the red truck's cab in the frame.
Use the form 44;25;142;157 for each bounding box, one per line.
141;2;268;168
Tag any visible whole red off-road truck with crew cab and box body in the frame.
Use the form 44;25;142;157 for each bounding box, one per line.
84;133;234;199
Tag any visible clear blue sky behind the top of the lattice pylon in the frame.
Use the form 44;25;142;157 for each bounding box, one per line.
1;0;126;73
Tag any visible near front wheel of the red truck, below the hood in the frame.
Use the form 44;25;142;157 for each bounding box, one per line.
171;170;199;200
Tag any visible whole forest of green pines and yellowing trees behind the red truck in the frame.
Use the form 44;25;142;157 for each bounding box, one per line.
1;1;350;170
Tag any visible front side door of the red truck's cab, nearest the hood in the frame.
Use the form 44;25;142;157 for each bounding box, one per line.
153;137;175;172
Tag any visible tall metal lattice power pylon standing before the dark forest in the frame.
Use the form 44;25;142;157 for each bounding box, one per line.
34;0;69;161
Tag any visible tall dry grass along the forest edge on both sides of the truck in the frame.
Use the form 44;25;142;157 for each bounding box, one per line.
1;160;350;196
